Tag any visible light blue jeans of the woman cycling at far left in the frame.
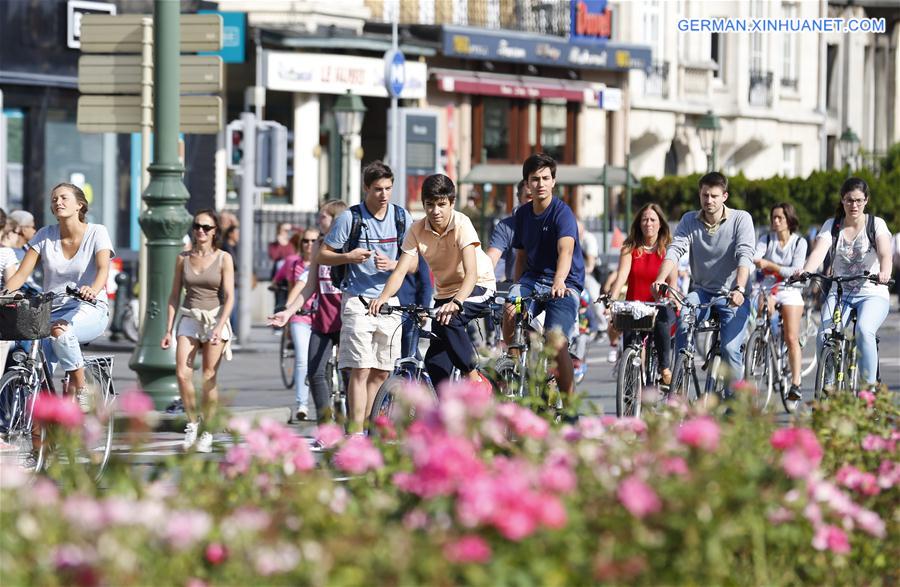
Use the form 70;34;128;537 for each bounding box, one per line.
44;300;109;372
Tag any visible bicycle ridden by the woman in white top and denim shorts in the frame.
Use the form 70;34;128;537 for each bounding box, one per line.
744;286;801;414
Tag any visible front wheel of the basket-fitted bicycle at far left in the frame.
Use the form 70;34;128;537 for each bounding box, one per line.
0;371;46;473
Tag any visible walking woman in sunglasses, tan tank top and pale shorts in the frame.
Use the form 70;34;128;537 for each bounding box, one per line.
160;210;234;452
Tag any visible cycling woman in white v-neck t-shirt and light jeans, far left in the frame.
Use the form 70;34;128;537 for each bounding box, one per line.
6;183;113;412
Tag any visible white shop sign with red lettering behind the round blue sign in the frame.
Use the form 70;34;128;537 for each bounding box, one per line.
263;51;428;99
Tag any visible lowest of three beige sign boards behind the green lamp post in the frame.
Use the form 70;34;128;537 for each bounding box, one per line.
78;96;222;134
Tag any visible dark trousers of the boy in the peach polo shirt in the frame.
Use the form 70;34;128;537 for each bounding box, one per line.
425;287;490;389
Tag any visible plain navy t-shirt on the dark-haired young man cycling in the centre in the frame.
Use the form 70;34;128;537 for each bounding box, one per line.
513;198;584;291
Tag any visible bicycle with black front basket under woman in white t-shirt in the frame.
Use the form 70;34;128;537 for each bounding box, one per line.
0;288;116;480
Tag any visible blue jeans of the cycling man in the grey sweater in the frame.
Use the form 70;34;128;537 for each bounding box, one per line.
675;289;750;381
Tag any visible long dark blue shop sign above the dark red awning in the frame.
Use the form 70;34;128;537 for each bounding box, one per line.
443;26;652;70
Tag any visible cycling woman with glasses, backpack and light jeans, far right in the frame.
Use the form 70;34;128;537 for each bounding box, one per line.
795;177;891;390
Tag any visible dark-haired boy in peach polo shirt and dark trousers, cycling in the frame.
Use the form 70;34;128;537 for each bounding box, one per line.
369;173;497;388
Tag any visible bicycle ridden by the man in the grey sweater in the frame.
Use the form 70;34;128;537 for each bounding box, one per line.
660;284;726;402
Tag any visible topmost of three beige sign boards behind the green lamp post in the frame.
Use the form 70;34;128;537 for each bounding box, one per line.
81;14;222;54
